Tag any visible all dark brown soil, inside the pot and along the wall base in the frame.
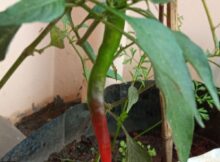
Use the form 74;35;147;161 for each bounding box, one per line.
16;82;220;162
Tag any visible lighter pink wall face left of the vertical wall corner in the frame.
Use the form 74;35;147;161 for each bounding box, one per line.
0;0;54;119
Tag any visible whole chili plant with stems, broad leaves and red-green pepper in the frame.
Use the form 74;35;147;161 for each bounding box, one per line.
0;0;220;162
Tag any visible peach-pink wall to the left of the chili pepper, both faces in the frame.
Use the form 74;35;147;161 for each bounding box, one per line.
0;0;122;122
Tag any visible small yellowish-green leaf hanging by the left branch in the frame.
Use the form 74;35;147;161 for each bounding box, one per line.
50;26;66;48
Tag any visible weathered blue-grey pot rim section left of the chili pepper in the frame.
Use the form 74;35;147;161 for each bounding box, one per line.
0;104;90;162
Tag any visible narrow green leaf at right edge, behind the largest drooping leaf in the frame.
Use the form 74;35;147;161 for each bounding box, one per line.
174;32;220;110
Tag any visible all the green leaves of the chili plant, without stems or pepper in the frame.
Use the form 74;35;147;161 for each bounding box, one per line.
0;0;220;162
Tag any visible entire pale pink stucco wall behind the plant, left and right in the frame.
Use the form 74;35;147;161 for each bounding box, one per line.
0;0;220;120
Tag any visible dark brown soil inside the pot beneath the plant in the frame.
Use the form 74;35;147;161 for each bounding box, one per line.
45;129;220;162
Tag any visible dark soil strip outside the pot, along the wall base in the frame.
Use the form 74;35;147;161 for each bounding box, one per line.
15;96;80;136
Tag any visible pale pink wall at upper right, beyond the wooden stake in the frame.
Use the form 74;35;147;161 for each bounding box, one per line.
179;0;220;87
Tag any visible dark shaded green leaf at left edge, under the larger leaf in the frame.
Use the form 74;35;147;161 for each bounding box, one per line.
0;26;20;61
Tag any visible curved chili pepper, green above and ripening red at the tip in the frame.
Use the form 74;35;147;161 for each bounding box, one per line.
88;0;126;162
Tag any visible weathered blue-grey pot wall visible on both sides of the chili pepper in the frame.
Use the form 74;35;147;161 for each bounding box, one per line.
0;84;160;162
